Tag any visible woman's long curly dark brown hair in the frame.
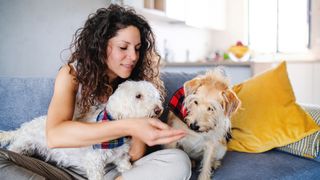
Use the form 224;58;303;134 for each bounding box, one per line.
68;5;165;114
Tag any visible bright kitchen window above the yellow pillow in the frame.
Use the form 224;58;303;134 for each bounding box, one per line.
248;0;310;53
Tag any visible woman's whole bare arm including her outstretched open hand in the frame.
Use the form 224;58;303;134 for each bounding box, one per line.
46;65;185;148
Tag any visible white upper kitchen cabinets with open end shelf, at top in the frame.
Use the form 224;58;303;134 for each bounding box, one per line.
125;0;226;30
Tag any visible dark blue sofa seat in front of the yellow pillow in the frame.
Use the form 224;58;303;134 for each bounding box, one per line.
208;150;320;180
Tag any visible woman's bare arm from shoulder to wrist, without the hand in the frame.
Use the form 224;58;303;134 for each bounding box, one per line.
46;65;132;147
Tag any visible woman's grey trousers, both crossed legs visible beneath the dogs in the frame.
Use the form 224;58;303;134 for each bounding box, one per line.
0;149;191;180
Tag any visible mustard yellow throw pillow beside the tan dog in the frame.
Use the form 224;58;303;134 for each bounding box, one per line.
228;62;320;153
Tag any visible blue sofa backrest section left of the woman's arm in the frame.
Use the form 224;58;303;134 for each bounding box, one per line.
0;77;54;130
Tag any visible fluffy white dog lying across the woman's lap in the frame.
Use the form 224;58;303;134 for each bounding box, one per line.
0;81;163;180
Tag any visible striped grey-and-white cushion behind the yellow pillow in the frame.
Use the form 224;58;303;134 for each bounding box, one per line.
277;105;320;162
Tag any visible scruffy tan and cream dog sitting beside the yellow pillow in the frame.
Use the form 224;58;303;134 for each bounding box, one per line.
166;68;240;180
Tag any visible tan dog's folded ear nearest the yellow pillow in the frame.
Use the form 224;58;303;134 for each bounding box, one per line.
222;89;241;117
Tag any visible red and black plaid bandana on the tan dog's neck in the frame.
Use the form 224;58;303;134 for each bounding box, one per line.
168;87;188;122
